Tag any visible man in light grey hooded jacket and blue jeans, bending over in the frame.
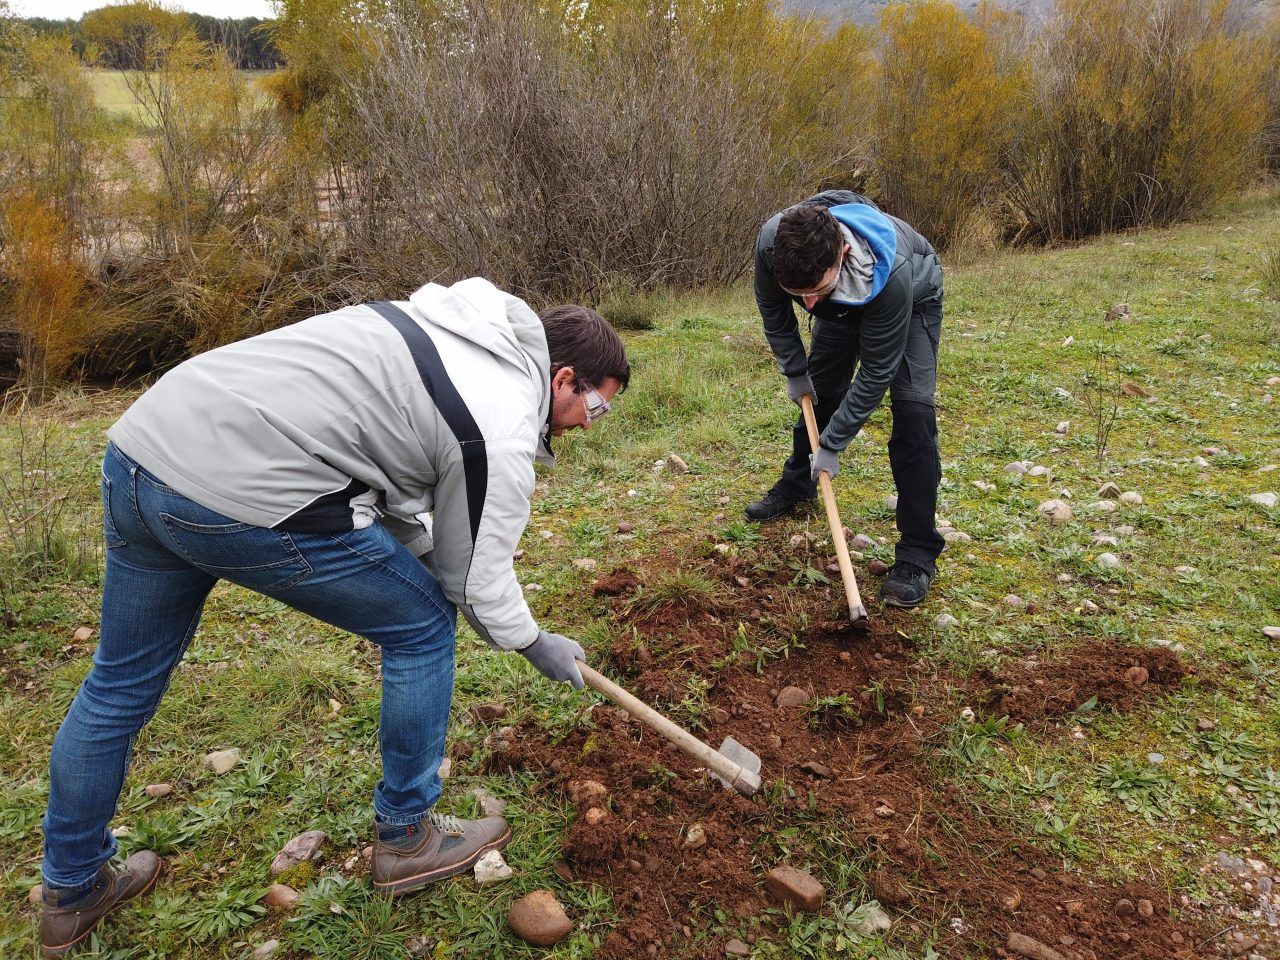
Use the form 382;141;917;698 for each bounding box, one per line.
41;278;631;956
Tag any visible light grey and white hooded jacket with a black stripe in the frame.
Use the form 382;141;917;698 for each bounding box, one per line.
108;278;553;650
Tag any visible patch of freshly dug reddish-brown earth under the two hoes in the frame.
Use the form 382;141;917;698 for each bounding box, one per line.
489;558;1208;960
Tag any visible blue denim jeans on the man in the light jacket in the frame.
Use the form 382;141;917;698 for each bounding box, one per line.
44;444;457;890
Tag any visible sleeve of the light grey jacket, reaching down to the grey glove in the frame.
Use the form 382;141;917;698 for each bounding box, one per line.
431;439;538;650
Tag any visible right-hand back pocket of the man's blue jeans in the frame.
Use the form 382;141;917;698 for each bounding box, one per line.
160;513;311;591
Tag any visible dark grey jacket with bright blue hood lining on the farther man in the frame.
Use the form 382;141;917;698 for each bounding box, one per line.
755;189;942;452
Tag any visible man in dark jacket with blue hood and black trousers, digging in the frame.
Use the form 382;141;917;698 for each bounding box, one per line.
746;189;943;607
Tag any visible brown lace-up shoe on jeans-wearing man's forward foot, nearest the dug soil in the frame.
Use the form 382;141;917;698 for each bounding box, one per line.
370;813;511;896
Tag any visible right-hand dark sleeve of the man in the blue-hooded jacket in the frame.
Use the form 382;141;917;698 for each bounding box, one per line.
818;261;913;452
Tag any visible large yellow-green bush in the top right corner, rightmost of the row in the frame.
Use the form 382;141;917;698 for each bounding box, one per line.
1007;0;1263;242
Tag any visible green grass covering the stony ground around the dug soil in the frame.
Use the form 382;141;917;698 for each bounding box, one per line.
0;192;1280;960
